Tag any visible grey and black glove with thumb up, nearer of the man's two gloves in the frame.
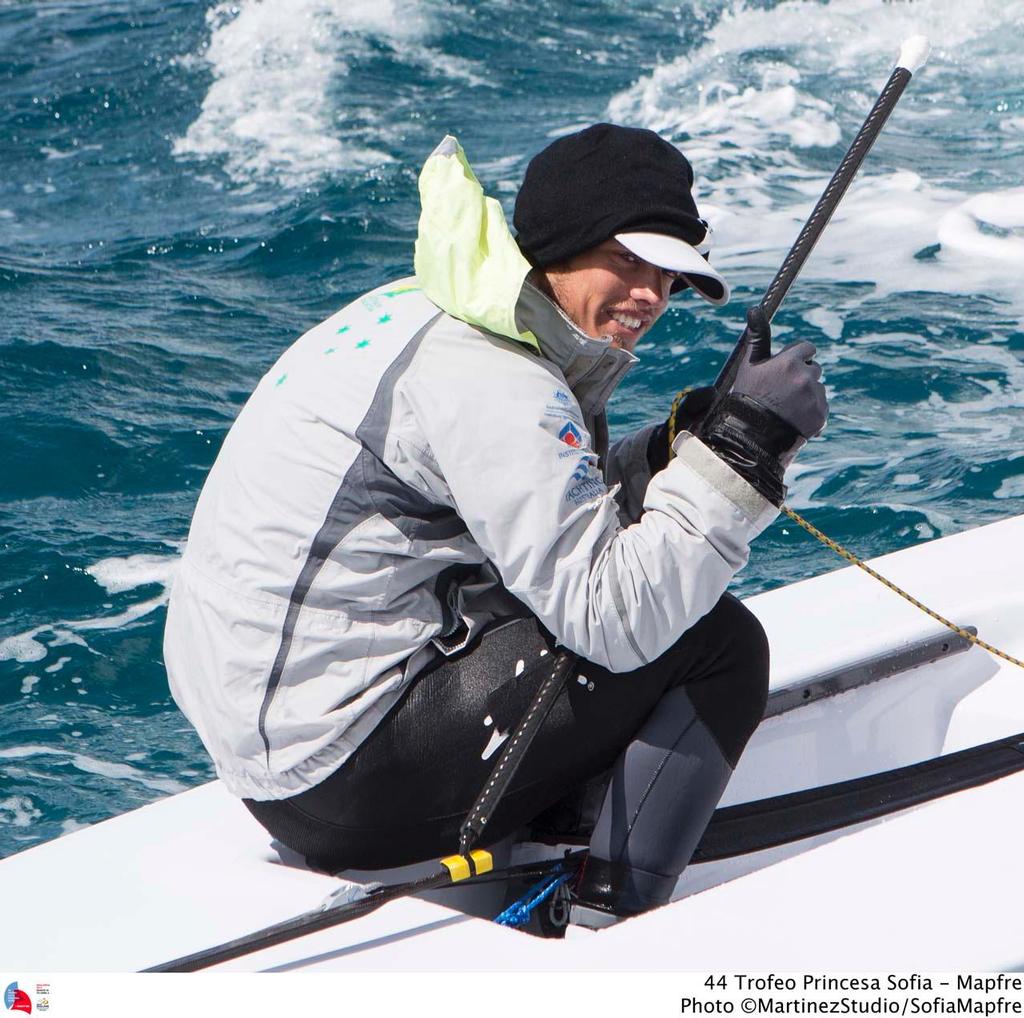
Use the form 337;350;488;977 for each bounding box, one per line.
698;306;828;506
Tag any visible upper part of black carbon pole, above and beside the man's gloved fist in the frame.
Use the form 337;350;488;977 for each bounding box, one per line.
715;60;912;396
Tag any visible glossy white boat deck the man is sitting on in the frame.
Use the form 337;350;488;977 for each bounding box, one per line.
0;517;1024;972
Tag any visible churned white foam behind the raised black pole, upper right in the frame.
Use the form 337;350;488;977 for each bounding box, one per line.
607;0;1024;309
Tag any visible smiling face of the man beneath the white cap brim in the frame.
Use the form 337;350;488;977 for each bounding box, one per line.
540;240;679;351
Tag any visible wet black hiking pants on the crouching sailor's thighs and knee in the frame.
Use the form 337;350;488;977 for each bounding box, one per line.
245;594;768;873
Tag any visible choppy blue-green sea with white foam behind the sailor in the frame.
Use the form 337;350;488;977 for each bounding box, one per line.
0;0;1024;854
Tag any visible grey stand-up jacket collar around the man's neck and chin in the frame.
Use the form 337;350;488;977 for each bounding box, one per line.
515;281;637;415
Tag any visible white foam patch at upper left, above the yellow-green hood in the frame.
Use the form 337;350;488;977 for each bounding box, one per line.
173;0;482;186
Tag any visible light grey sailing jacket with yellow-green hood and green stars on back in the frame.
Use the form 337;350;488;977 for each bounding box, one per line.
164;137;776;799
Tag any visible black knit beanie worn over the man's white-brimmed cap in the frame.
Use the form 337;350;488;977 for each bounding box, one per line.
512;124;707;268
